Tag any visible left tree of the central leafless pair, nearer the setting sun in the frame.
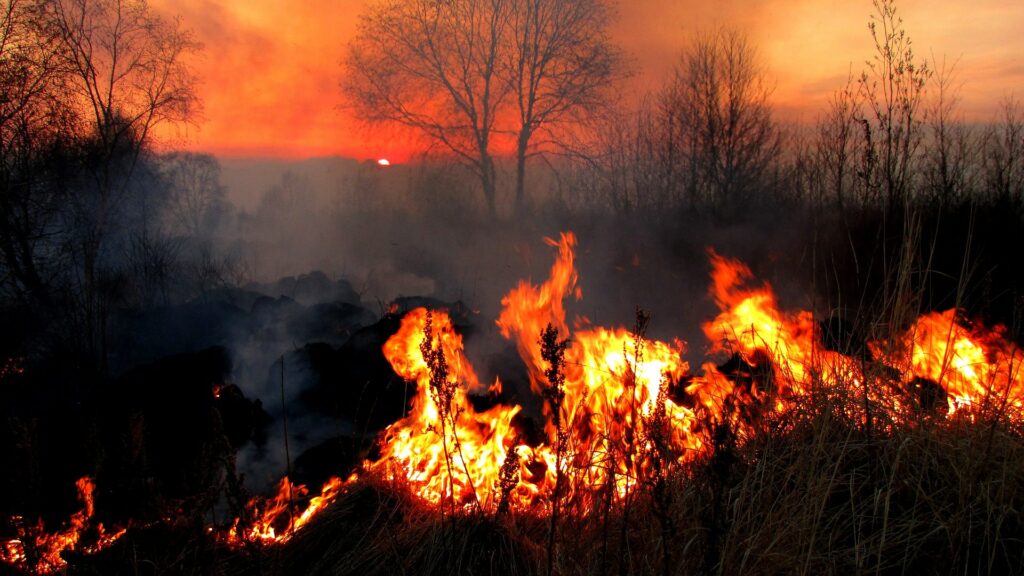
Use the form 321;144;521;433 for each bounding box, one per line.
343;0;511;216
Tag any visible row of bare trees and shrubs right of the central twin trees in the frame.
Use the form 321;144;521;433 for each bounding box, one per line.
569;22;1024;217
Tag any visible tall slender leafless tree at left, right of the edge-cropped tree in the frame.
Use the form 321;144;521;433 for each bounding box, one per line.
41;0;198;358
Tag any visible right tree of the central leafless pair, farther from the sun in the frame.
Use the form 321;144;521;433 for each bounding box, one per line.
508;0;622;212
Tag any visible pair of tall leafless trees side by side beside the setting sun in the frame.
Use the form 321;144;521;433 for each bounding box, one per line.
342;0;621;216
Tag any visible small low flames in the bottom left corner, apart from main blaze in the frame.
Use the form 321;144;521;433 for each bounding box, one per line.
0;477;125;574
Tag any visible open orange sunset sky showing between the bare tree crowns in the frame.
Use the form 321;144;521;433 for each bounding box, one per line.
152;0;1024;159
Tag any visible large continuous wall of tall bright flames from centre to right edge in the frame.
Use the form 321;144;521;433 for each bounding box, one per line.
356;233;1024;509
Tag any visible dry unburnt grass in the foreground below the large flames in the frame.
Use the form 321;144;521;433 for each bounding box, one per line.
272;385;1024;576
